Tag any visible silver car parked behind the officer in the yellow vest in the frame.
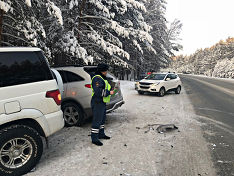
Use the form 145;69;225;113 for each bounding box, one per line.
52;66;124;126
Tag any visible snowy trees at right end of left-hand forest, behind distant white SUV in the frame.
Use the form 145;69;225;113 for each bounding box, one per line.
144;0;182;70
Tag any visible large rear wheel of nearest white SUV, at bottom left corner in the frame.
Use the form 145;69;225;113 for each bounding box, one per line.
0;125;43;176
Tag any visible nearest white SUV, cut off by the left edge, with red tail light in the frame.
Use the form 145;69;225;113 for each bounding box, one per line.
0;47;64;176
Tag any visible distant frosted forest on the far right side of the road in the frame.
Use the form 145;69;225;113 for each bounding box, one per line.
170;38;234;78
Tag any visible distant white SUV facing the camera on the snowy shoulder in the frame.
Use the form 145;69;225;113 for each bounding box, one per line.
136;72;181;97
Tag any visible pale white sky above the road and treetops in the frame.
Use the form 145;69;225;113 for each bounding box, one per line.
166;0;234;55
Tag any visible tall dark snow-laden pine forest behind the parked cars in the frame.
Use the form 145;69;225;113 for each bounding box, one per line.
0;0;182;78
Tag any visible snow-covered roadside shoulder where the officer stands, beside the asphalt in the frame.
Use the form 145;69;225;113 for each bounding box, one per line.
27;81;216;176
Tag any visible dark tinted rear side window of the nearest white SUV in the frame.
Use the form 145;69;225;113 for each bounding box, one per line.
0;51;53;87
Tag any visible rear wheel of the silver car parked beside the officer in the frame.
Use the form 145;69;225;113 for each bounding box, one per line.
62;102;84;127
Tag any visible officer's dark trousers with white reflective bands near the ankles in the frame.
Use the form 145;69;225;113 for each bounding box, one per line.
91;98;106;141
